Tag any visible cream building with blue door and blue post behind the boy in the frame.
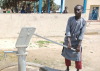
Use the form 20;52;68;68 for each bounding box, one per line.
65;0;100;20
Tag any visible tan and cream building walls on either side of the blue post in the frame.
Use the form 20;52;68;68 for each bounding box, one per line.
65;0;100;20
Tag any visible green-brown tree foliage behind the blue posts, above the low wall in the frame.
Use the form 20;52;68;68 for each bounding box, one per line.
0;0;59;12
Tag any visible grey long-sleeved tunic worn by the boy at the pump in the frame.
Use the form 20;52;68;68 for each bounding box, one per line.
62;16;86;61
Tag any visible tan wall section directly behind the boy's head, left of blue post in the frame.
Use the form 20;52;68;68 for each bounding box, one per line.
65;0;84;13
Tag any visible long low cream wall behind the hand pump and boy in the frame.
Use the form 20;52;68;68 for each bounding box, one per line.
0;13;86;38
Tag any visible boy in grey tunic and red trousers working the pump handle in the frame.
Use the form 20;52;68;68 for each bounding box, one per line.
62;5;86;71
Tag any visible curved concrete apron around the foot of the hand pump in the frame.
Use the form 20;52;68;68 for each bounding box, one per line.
0;62;63;71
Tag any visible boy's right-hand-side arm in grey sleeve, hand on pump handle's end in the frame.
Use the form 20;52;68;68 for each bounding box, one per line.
76;21;87;52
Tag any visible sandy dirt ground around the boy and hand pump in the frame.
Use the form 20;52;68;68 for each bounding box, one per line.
0;25;100;71
